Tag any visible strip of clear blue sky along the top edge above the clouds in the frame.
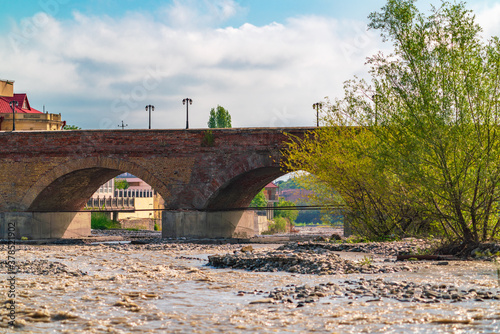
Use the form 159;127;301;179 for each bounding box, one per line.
0;0;384;29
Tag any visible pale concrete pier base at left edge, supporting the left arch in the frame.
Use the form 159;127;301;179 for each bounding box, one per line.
0;212;90;240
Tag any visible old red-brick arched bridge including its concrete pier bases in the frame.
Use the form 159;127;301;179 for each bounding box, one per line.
0;128;311;239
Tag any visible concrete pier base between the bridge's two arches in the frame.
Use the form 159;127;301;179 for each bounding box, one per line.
162;210;258;238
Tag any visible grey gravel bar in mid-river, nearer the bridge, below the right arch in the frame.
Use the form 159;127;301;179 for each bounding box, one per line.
208;242;413;275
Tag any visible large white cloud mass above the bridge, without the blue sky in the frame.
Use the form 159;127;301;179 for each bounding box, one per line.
0;0;380;128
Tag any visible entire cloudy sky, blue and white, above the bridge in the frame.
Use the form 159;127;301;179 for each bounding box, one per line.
0;0;500;129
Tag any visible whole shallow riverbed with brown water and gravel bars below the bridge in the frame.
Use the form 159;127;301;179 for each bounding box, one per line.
0;240;500;333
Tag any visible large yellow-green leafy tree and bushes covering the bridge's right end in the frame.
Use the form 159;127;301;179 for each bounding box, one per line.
284;0;500;243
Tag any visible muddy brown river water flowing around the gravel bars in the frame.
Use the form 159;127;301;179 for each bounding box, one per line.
0;245;500;333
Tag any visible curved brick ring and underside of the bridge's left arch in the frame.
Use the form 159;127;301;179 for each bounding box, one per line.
22;157;166;212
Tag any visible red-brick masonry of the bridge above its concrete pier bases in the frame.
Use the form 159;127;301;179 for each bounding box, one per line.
0;128;313;211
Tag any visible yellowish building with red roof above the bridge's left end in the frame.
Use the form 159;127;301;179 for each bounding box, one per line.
0;80;66;131
